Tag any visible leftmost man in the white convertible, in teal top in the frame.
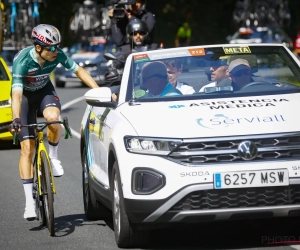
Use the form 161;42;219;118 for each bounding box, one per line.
142;62;182;97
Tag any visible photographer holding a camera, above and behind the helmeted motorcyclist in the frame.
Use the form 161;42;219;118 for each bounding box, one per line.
108;0;155;47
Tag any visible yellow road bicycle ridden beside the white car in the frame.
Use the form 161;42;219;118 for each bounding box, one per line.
13;117;72;236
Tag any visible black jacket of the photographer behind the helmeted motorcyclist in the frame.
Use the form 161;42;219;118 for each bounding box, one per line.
111;11;155;47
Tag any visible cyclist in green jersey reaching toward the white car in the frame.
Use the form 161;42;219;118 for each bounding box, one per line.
10;24;98;220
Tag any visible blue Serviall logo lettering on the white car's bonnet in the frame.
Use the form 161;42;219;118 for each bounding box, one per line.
196;114;286;129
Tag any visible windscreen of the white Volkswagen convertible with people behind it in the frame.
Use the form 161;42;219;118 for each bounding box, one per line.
126;46;300;101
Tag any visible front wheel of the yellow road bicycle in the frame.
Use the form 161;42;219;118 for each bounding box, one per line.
40;151;54;236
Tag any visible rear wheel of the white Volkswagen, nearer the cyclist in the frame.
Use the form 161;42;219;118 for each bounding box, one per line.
82;148;110;220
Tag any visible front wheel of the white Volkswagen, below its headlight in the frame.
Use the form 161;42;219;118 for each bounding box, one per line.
111;161;150;248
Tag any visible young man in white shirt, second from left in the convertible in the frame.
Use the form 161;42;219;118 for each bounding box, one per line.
164;59;195;95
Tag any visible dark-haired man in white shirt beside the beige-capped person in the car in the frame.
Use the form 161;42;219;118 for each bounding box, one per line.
199;59;229;92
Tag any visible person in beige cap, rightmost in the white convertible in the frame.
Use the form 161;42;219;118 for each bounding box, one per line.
228;58;254;90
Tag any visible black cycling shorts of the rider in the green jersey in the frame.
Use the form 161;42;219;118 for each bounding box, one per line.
18;82;61;142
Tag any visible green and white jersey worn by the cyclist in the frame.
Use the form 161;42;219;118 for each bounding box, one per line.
12;46;78;91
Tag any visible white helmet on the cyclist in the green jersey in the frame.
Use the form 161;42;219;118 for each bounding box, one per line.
31;24;61;46
